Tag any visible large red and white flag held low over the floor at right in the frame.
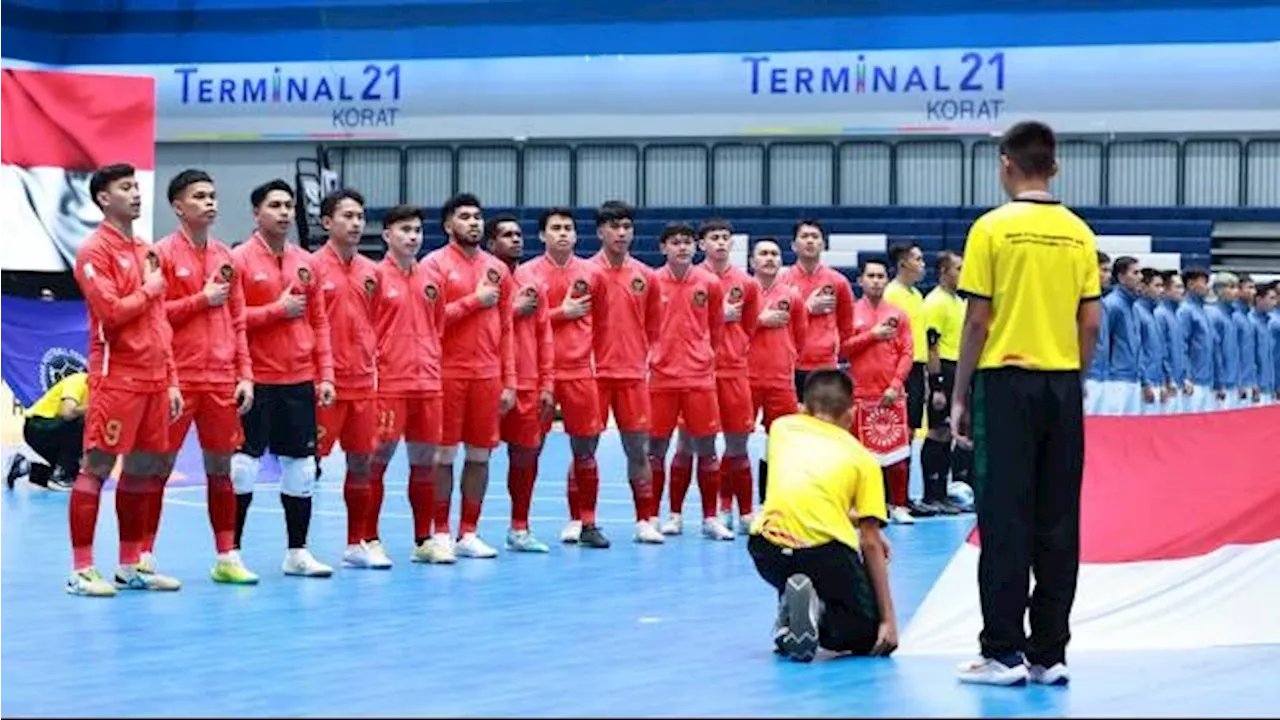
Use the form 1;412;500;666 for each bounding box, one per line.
900;406;1280;655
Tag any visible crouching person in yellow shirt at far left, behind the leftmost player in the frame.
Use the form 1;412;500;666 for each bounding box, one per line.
5;373;88;491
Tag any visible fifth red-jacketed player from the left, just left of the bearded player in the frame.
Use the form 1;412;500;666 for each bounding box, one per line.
365;205;453;562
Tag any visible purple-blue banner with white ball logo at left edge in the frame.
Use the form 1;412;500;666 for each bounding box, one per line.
0;296;88;407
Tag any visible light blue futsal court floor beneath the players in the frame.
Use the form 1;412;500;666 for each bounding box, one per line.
0;427;1280;717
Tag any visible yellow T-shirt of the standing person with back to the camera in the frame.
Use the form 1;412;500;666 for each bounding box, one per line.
960;200;1102;370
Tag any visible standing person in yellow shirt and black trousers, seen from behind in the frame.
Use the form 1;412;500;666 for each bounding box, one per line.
951;122;1102;685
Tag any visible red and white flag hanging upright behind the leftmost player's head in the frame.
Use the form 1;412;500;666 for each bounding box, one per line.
0;69;156;272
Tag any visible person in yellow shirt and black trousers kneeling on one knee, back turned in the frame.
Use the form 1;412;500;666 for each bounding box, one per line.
748;370;897;662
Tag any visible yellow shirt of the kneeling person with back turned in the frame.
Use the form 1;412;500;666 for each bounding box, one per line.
750;414;888;550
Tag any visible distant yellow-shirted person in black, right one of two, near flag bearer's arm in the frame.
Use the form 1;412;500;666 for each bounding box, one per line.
920;250;972;515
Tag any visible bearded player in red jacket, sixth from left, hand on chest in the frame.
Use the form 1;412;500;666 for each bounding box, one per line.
424;193;516;559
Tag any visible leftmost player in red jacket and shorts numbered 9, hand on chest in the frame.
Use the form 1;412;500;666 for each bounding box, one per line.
67;164;182;597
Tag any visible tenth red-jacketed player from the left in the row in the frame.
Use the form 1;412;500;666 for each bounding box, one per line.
649;224;733;541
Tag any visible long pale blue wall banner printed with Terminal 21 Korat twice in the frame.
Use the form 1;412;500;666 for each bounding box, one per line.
2;44;1280;142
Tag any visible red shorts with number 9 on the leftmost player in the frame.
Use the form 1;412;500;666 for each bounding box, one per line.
84;383;169;455
